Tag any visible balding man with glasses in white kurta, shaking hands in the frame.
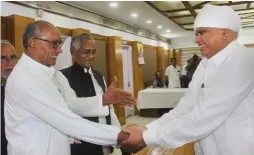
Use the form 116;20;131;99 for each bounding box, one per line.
5;21;135;155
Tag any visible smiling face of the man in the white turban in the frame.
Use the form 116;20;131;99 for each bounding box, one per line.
195;27;225;59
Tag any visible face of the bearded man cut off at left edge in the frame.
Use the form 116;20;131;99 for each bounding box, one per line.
1;44;18;78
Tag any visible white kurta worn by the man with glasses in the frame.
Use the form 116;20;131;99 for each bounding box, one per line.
5;54;120;155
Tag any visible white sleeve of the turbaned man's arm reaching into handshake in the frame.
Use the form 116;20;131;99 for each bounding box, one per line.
143;57;254;148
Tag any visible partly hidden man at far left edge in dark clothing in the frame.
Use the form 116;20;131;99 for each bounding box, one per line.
1;40;17;155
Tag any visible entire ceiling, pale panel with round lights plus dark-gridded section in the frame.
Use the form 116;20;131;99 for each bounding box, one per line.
62;1;254;38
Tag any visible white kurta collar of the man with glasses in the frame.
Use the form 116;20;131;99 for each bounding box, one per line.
22;53;56;77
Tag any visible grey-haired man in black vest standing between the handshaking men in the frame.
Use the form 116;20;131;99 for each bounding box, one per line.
61;34;130;155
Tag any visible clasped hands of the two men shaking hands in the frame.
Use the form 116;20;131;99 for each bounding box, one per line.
117;125;147;153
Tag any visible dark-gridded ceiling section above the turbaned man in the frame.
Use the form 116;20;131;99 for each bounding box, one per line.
146;1;254;30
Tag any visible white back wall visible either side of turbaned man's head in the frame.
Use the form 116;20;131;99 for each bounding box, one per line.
171;28;254;48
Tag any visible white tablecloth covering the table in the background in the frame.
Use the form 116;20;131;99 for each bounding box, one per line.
138;88;187;109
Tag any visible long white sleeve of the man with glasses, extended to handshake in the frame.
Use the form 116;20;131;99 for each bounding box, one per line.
8;80;120;145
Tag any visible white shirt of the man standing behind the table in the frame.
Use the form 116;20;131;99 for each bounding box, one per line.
165;65;181;88
